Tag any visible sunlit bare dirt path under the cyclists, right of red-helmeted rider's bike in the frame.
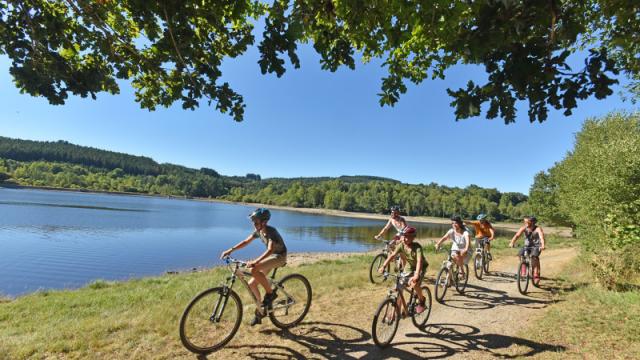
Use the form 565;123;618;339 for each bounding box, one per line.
353;248;576;359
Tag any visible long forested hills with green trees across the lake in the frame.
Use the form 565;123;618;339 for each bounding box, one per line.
0;137;529;220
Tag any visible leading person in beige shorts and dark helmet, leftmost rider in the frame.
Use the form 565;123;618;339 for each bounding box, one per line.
220;208;287;326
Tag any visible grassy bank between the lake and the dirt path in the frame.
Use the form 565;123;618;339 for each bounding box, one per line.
0;238;571;359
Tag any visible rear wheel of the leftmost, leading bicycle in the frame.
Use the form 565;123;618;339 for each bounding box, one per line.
269;274;311;329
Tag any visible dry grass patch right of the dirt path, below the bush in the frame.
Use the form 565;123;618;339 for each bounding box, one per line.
522;258;640;359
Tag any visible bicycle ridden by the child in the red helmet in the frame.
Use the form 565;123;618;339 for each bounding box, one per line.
371;272;431;347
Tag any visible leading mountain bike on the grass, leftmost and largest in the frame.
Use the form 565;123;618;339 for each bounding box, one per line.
180;256;312;354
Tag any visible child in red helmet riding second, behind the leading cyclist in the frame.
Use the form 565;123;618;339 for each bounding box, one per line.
378;226;429;314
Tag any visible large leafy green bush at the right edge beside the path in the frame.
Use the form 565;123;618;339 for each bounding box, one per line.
529;113;640;290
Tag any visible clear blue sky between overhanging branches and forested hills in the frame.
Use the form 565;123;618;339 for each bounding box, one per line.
0;42;637;193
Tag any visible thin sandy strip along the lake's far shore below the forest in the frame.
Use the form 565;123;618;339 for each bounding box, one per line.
0;182;572;237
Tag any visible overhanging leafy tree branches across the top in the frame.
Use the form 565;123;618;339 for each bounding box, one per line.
0;0;640;123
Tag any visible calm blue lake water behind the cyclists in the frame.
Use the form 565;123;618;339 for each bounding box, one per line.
0;188;510;296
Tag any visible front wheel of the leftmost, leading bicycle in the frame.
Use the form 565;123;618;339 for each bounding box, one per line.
180;287;242;354
